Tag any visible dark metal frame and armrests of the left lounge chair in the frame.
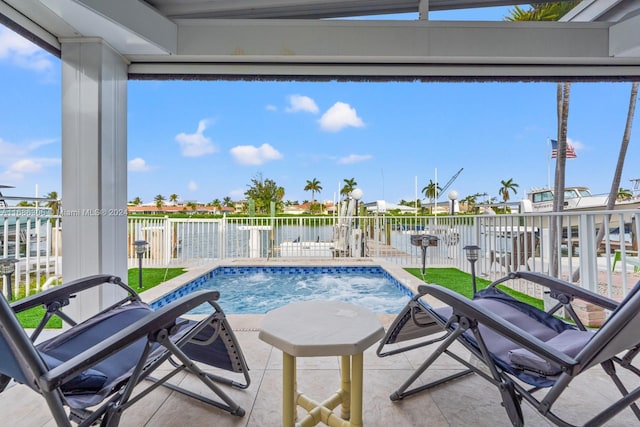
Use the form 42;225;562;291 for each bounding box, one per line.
0;275;250;426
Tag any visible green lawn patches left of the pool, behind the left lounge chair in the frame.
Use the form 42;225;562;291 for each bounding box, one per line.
18;268;186;328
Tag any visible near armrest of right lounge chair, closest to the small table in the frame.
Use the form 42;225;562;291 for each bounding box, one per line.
418;285;578;370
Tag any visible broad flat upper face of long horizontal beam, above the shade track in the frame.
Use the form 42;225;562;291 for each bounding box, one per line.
172;20;611;62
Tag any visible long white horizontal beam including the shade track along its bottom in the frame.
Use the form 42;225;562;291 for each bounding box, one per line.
128;20;640;79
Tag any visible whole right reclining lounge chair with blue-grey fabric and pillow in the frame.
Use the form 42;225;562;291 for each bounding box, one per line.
377;271;640;426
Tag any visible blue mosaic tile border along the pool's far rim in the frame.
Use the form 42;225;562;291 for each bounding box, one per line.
151;266;415;310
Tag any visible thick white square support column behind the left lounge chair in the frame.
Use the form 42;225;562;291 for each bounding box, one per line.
61;39;127;319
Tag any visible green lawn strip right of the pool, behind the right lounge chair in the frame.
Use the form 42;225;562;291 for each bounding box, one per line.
405;268;544;310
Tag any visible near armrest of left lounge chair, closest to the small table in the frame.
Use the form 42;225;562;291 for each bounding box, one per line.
41;290;220;391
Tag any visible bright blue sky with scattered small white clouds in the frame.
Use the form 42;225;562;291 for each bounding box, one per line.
0;8;640;207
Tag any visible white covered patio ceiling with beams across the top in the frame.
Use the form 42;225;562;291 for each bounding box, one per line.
0;0;640;81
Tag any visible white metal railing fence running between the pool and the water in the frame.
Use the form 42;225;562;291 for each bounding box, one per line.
0;210;640;298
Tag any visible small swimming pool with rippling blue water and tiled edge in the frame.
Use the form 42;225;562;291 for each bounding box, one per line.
151;266;413;314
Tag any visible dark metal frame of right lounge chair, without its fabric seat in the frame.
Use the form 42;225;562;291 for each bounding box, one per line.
377;271;640;426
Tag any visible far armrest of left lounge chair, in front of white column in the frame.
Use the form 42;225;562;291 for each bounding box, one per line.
11;274;138;313
